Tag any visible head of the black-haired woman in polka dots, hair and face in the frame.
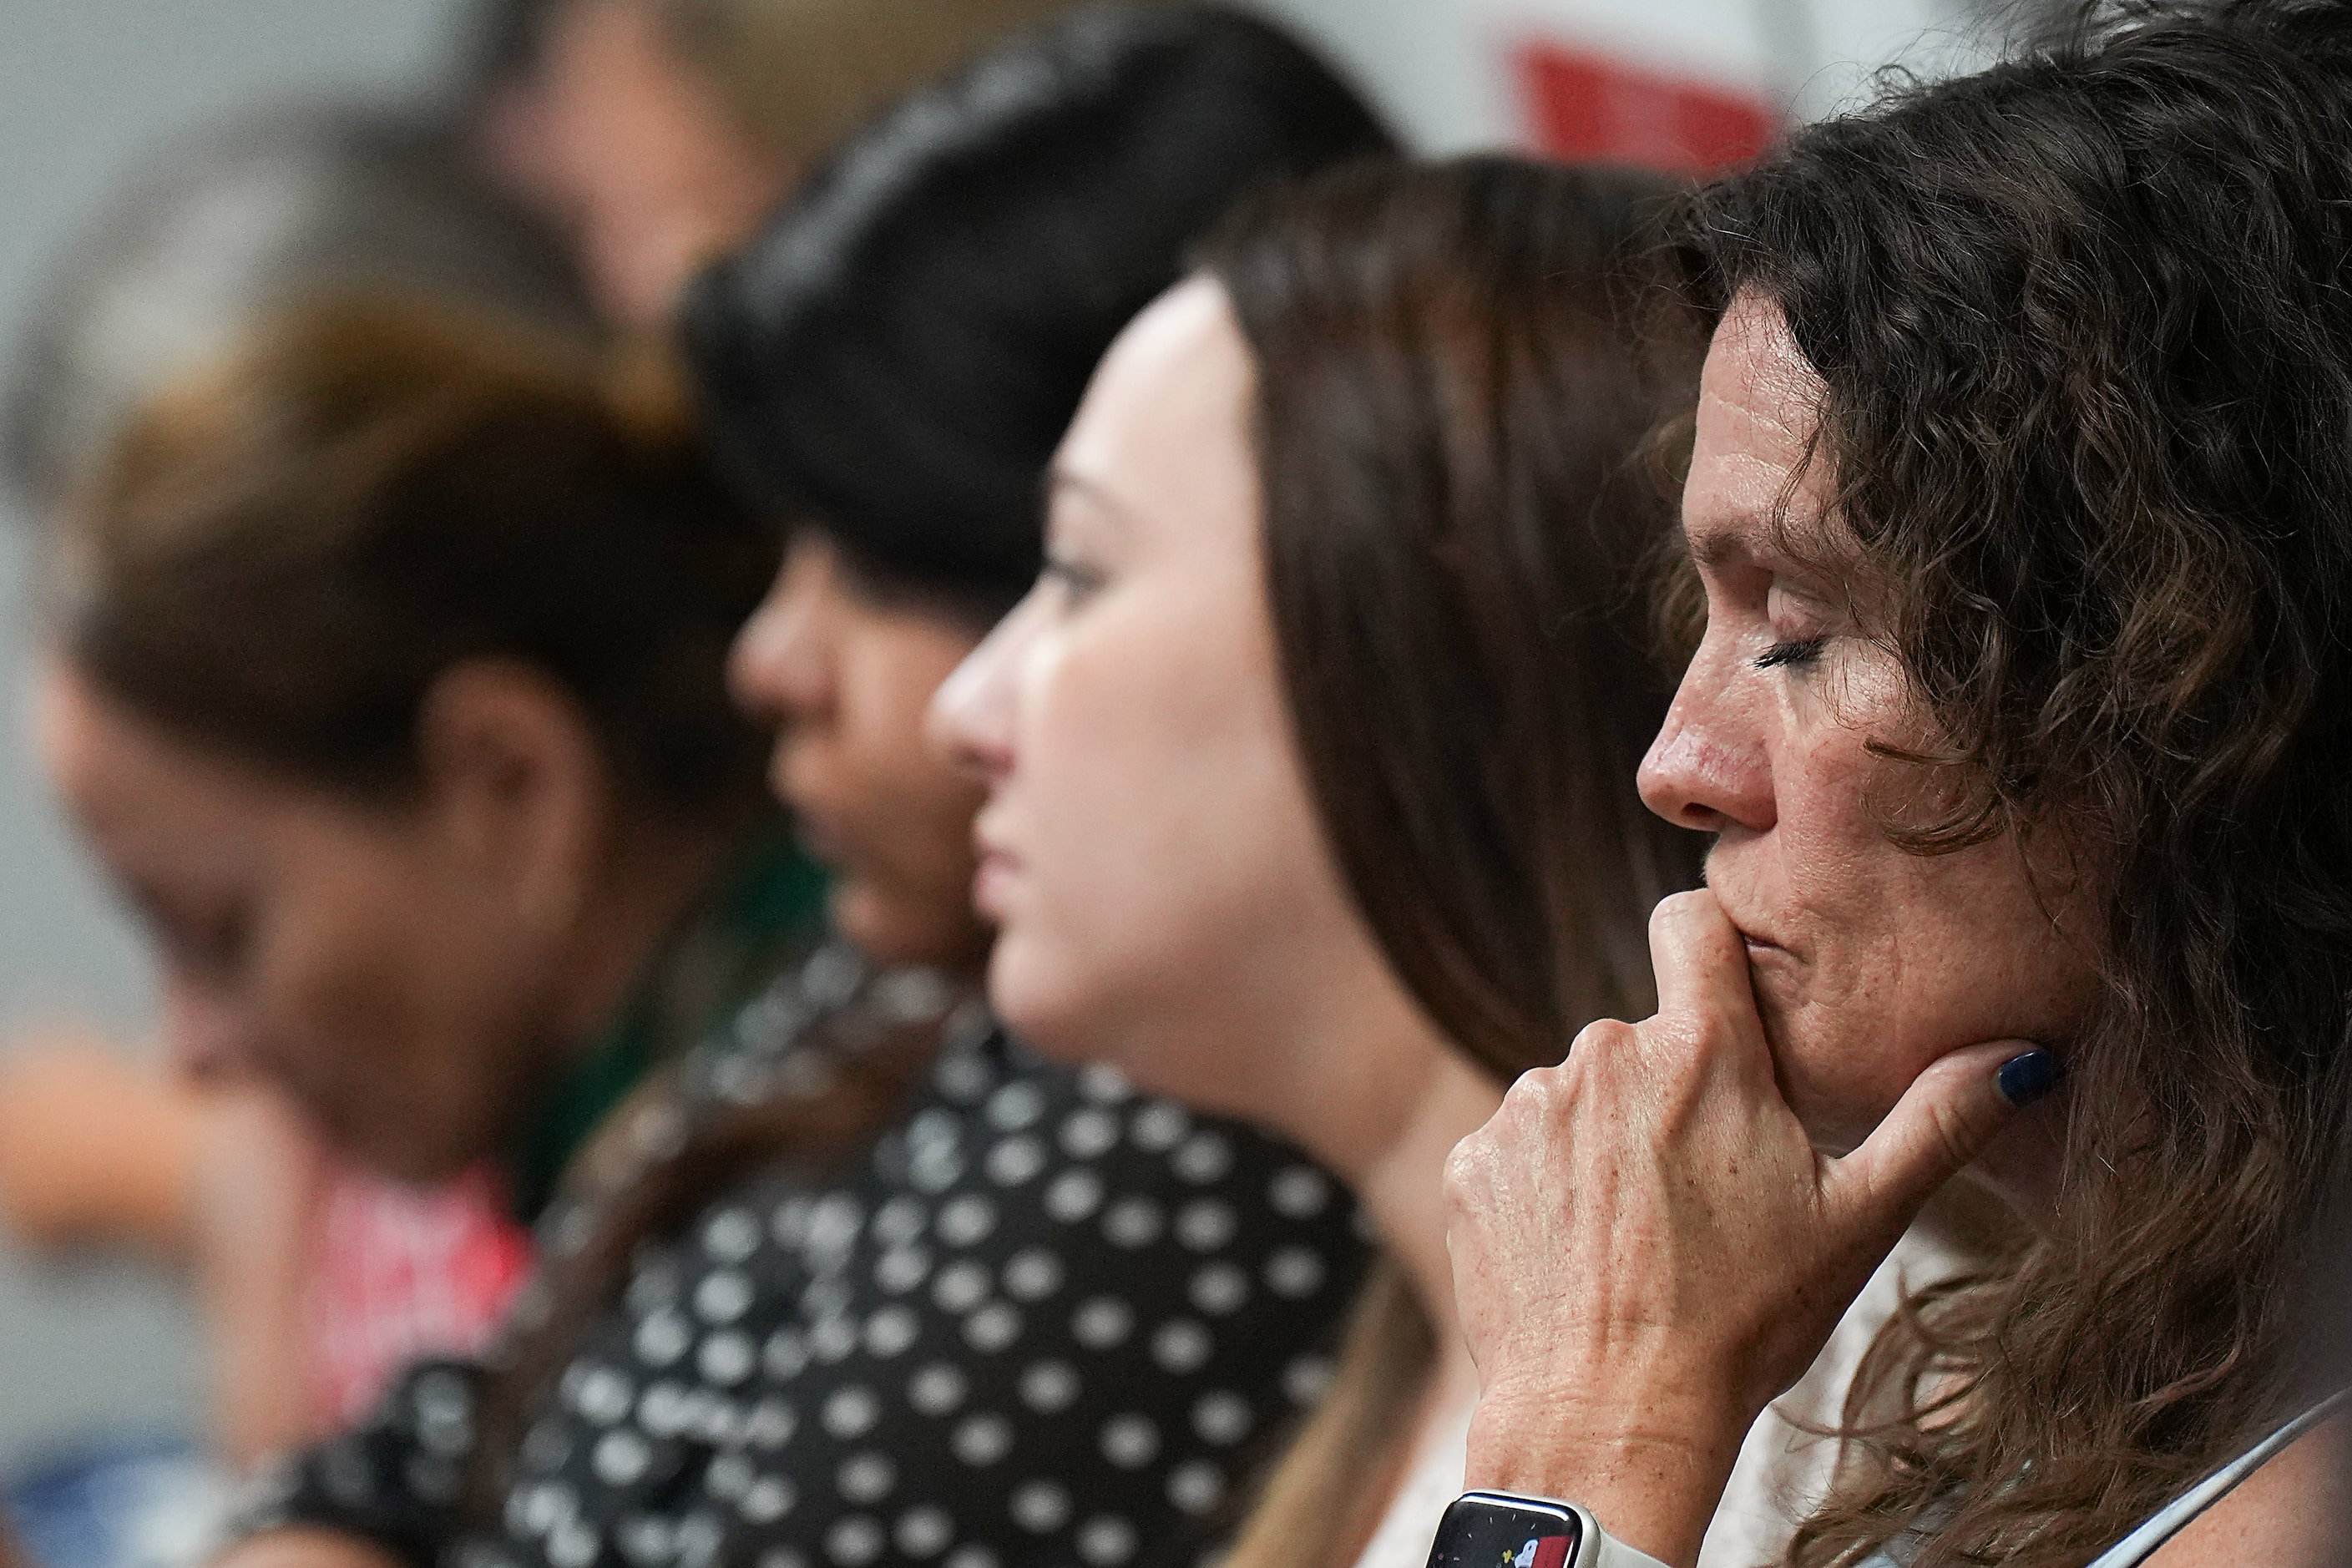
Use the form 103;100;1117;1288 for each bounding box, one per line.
687;5;1388;962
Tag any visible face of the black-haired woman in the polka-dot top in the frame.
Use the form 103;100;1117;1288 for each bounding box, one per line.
731;529;988;969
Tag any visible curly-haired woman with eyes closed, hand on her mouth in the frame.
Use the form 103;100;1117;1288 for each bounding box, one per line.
1451;0;2352;1565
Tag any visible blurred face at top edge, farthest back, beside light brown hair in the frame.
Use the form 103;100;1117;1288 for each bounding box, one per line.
484;0;788;326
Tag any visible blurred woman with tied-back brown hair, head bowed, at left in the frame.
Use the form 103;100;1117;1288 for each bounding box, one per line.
40;294;823;1542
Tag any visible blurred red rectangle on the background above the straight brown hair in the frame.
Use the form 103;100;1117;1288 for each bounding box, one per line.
1515;43;1780;174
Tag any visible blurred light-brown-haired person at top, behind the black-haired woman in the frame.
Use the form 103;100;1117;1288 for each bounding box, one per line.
468;0;1070;329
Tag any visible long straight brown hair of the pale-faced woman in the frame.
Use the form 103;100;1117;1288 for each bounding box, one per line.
1206;158;1703;1568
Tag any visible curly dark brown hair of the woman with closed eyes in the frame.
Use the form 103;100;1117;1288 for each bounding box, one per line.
1684;0;2352;1568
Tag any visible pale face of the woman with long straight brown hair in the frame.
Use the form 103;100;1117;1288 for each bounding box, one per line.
938;282;1409;1112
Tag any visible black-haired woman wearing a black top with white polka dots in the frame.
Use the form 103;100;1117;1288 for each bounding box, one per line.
211;7;1390;1568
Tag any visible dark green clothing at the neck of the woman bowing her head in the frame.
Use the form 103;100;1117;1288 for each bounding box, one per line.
508;825;828;1225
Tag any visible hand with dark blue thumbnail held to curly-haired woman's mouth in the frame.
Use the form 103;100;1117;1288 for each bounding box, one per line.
1446;893;2051;1563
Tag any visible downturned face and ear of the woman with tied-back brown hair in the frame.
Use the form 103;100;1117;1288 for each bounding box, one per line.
38;658;597;1182
